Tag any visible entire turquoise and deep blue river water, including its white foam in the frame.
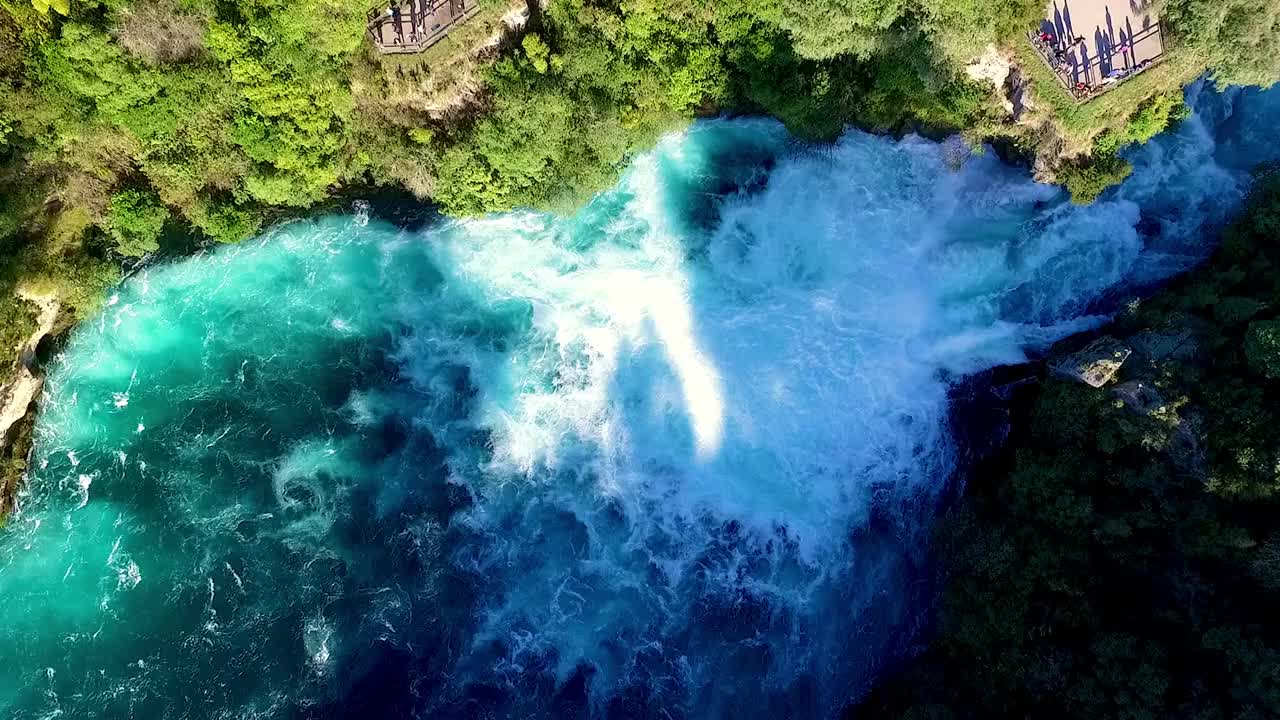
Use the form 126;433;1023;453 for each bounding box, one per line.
0;82;1280;719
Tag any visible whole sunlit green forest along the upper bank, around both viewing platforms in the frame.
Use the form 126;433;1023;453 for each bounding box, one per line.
0;0;1280;343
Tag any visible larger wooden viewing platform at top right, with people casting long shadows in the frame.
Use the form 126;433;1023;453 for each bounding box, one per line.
1028;0;1165;102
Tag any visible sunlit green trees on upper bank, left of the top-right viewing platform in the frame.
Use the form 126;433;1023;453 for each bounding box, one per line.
0;0;1036;229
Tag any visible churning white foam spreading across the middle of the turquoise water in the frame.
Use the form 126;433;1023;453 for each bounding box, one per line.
403;85;1269;707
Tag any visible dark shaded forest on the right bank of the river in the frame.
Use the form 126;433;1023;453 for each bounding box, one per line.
859;170;1280;719
